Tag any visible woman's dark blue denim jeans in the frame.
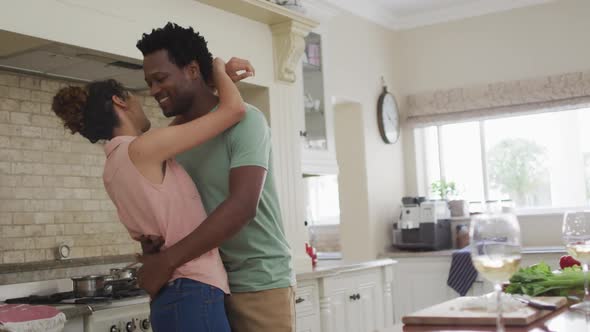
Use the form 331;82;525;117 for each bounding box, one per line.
150;278;230;332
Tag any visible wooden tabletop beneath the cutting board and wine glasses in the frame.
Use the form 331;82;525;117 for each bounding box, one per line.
382;308;590;332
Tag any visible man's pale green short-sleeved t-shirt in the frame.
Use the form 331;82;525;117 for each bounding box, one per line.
176;105;294;292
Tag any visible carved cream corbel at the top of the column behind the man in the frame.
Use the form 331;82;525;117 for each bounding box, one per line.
271;21;313;83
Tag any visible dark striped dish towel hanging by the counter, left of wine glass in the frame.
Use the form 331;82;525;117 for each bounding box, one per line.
447;246;477;296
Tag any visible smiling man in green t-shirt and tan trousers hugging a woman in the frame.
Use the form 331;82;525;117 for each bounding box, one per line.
137;23;295;332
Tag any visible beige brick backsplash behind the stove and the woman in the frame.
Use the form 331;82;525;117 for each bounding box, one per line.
0;71;169;269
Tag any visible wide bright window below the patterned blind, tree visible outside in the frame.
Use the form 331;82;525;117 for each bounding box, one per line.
414;108;590;213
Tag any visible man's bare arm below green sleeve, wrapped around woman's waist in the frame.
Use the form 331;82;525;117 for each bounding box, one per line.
138;166;267;298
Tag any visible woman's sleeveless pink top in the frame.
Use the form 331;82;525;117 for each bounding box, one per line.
103;136;229;294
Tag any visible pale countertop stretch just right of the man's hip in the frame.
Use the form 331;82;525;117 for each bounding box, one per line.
296;258;396;281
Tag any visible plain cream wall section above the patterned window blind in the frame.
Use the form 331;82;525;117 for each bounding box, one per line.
398;0;590;94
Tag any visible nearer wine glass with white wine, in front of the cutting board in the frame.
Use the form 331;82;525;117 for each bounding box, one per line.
469;213;521;332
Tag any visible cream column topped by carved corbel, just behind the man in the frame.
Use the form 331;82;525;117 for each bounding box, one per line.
270;21;313;271
